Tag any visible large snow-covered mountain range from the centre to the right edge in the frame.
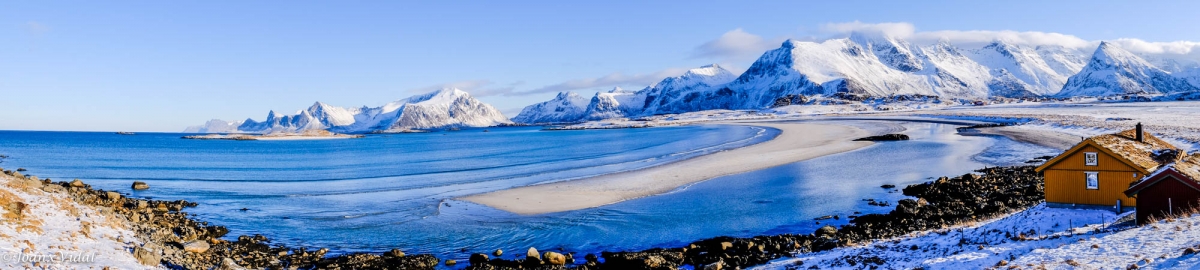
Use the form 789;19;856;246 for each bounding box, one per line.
506;32;1200;124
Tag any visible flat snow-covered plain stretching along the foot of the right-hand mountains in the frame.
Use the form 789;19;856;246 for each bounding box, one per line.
562;98;1200;151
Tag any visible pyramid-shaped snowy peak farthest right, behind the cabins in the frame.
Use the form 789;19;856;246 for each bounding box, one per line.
1057;42;1200;97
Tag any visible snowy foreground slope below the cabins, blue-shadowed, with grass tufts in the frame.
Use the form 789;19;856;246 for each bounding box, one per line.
755;205;1200;269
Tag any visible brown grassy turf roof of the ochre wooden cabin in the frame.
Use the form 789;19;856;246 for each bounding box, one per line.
1037;130;1180;174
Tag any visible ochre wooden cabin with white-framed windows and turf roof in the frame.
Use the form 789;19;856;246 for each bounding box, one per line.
1037;122;1178;211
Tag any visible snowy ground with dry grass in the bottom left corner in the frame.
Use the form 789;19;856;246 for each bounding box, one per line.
0;174;154;269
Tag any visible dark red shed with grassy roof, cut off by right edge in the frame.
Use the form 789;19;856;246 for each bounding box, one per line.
1124;154;1200;224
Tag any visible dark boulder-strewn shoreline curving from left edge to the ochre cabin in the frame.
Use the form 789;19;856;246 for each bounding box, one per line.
5;167;1043;270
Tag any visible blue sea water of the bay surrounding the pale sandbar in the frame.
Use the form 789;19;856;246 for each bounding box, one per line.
0;122;1054;264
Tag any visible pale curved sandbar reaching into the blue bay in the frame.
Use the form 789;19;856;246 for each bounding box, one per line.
460;122;872;215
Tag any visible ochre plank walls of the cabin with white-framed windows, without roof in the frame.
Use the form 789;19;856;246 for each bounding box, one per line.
1043;145;1144;206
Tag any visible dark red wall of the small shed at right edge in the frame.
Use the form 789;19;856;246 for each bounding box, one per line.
1138;175;1200;224
